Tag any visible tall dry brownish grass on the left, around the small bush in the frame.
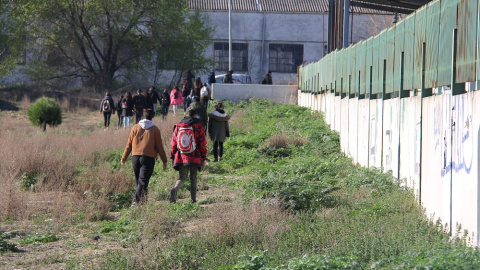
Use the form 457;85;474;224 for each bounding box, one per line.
0;107;180;224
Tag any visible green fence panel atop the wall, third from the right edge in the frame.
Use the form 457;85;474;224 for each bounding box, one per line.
425;0;441;88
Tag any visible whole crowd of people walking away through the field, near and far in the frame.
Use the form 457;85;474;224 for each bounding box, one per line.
110;71;230;205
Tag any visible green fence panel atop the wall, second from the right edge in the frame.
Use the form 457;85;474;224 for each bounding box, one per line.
437;0;459;86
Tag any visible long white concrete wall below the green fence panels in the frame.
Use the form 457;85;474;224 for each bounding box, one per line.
298;83;480;245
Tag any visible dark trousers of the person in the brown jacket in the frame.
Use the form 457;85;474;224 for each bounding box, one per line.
132;156;155;204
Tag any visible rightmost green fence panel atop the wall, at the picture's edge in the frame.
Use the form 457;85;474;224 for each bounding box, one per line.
456;0;478;83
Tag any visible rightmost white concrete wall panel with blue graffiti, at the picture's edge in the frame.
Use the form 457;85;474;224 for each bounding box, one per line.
452;92;480;244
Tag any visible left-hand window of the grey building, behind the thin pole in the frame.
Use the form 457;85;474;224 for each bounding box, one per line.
213;42;248;71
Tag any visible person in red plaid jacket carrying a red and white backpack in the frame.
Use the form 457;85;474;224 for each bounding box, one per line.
170;109;207;203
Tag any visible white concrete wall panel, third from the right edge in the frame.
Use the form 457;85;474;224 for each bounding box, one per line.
399;96;421;195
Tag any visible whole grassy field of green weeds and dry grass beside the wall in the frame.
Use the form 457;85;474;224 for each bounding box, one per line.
0;96;480;269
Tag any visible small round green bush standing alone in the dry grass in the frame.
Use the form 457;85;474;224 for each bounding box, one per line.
27;97;62;131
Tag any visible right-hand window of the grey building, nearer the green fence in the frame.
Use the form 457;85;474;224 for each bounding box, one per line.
269;44;303;73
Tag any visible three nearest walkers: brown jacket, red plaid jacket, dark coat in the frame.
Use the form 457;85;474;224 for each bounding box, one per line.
121;100;230;205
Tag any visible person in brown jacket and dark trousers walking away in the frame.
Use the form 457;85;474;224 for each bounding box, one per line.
120;109;167;205
